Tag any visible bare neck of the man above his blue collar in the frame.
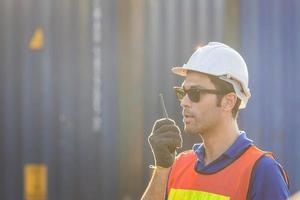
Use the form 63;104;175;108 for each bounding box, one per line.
202;120;240;165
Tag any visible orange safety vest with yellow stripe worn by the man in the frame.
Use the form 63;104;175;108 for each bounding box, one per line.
167;145;288;200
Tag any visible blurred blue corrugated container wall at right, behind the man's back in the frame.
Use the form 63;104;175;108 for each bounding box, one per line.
240;0;300;195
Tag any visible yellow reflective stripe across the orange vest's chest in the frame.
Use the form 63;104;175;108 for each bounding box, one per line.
168;188;230;200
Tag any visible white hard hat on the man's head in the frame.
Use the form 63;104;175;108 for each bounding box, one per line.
172;42;251;109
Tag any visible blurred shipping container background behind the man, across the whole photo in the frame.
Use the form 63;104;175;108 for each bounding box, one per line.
0;0;300;200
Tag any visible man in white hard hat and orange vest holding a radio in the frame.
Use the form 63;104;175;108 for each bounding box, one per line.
142;42;289;200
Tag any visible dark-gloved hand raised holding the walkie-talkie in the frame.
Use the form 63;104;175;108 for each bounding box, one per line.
148;118;182;168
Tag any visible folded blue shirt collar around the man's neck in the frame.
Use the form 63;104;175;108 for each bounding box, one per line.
193;131;253;161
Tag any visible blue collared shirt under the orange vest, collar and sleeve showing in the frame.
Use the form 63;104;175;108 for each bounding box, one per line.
193;131;289;200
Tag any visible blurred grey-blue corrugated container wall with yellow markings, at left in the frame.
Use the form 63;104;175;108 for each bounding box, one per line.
0;0;118;200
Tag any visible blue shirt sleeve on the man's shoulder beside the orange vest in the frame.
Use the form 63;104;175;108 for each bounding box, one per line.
249;156;289;200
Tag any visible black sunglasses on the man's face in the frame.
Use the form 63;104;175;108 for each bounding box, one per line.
174;86;225;103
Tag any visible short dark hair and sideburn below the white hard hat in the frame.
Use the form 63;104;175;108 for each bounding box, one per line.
208;75;241;118
